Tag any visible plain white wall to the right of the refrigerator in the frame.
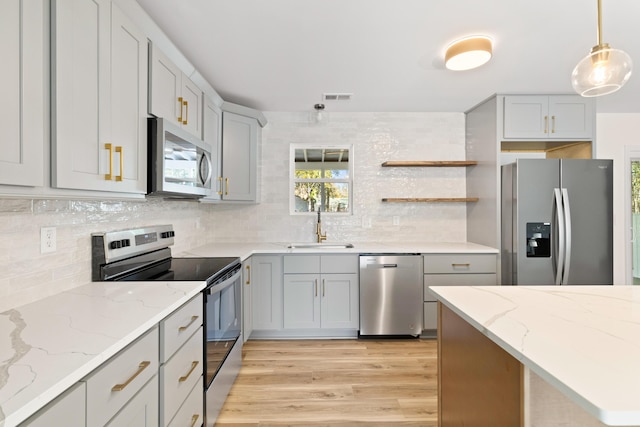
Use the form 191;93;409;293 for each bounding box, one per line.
595;114;640;285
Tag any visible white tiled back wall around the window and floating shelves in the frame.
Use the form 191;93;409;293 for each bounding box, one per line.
208;112;466;243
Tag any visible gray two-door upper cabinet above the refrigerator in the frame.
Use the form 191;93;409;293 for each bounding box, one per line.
503;95;595;141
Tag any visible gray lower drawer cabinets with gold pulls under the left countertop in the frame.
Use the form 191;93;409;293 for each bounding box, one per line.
20;294;204;427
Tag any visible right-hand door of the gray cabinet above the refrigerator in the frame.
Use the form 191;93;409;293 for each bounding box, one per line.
549;95;595;140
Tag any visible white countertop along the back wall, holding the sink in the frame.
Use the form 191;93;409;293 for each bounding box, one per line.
176;242;498;260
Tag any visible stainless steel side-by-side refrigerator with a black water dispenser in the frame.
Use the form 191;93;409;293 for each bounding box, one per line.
501;159;613;285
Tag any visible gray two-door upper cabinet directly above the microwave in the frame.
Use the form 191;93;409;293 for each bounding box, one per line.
149;43;203;139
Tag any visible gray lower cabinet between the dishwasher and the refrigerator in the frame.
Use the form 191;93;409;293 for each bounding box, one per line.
423;254;498;330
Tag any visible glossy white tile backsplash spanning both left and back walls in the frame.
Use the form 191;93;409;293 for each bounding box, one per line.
0;110;466;311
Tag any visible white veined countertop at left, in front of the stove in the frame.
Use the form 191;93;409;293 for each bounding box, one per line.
0;282;205;427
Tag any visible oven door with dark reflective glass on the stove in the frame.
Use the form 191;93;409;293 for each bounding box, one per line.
204;268;242;390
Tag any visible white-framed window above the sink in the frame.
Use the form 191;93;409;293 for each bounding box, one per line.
290;144;353;214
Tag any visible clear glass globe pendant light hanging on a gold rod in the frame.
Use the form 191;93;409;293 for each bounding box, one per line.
571;0;633;97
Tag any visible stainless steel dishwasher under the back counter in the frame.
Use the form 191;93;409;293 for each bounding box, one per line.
360;254;423;336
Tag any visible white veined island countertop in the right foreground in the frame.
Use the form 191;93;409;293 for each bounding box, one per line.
430;286;640;426
